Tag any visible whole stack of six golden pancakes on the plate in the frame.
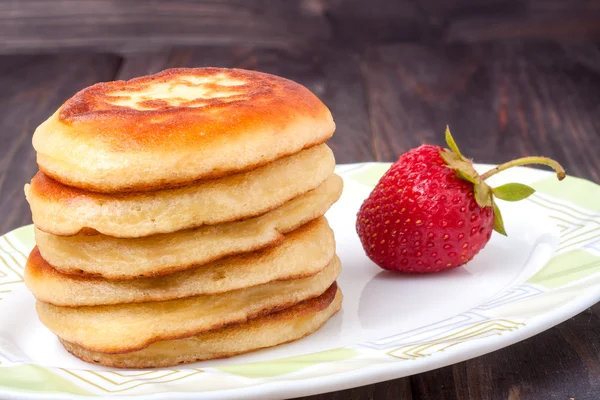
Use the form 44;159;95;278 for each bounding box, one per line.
25;68;342;368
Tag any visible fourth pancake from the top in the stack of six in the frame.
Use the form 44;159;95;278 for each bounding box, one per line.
24;217;335;307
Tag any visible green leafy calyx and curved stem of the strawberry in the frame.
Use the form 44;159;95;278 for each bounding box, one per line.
440;126;566;236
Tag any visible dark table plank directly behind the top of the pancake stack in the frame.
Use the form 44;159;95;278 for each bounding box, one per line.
118;46;375;163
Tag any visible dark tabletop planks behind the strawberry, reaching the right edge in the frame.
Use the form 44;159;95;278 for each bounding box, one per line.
364;42;600;181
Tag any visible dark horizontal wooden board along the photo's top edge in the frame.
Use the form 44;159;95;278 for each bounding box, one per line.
0;0;600;54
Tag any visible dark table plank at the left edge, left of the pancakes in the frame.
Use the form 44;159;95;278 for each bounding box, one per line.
0;55;120;233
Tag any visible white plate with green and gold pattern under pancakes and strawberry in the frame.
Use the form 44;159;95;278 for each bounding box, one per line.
0;163;600;399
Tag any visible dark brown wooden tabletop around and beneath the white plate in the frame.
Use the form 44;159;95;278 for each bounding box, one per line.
0;1;600;400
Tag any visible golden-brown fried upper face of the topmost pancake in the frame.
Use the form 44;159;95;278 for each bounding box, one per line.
58;68;323;132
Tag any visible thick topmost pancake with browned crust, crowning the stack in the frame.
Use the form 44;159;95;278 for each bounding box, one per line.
33;68;335;193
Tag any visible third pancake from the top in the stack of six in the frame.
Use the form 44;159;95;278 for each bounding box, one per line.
35;175;343;279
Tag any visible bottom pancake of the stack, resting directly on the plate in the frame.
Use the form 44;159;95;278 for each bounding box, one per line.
61;284;343;368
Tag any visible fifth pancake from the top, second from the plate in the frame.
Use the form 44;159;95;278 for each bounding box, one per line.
36;256;341;353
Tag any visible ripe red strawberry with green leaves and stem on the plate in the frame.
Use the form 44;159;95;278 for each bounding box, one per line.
356;128;565;272
